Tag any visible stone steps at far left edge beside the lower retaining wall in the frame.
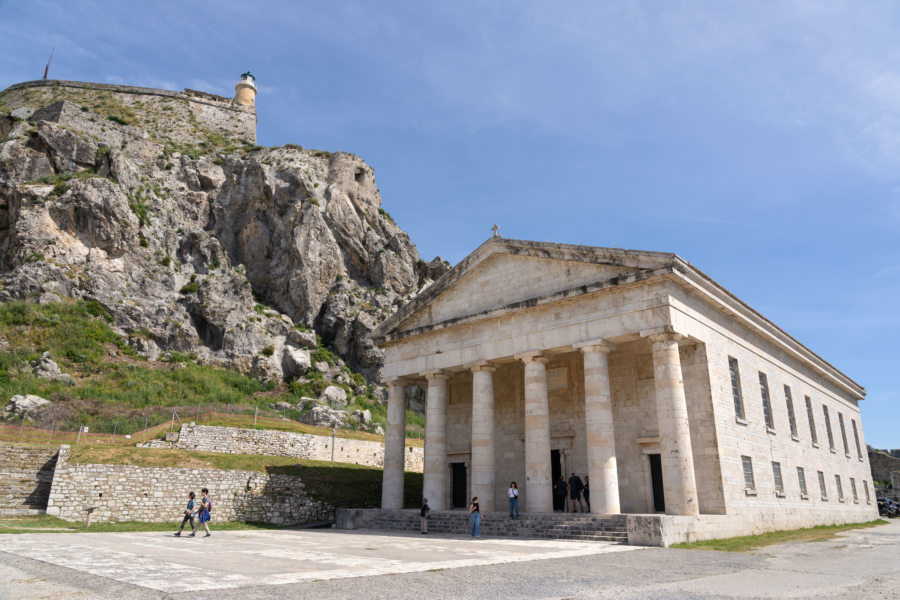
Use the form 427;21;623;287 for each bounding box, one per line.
0;445;58;517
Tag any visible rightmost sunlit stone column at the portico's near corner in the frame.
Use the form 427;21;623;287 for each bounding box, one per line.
650;333;700;515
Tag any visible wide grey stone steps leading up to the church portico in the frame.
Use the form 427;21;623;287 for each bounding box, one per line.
367;510;628;544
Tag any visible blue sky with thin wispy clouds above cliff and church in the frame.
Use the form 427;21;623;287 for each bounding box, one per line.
0;0;900;447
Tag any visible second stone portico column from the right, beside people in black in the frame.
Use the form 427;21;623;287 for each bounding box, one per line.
579;344;620;515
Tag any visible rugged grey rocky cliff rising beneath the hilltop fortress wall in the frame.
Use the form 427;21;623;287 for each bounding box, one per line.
0;82;447;381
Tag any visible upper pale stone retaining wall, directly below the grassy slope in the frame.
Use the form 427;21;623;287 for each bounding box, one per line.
139;424;424;473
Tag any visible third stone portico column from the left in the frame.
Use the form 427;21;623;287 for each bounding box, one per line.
472;364;496;510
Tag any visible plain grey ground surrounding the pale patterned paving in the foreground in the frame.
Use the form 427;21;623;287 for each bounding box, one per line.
0;521;900;600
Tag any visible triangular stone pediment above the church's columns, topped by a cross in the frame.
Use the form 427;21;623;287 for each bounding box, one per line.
376;238;674;337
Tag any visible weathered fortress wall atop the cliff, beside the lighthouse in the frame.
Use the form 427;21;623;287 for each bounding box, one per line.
0;80;256;144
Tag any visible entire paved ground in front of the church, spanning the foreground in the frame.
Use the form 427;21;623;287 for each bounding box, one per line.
0;522;900;599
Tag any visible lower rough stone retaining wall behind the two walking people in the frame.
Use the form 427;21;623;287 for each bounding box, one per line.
47;446;328;525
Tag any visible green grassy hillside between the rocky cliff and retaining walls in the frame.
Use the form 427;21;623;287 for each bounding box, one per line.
0;301;424;438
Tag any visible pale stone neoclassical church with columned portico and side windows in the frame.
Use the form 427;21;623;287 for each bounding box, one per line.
375;236;877;543
